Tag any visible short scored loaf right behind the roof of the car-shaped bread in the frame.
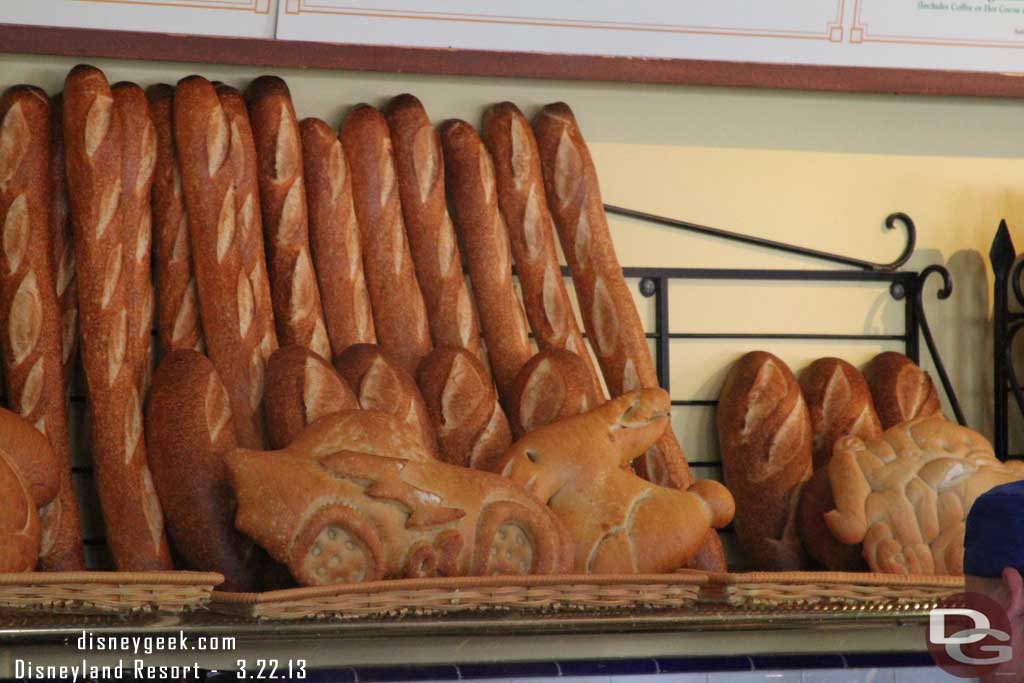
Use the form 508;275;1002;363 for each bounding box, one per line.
334;344;437;454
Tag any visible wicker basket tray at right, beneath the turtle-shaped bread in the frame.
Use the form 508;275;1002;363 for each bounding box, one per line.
700;571;964;609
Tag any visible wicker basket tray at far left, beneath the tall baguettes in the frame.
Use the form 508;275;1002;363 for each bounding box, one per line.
0;571;224;614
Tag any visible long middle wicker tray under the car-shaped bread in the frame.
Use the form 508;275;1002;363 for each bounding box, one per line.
210;572;707;621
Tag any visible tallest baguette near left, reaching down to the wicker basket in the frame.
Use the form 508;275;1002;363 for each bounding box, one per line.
63;67;171;571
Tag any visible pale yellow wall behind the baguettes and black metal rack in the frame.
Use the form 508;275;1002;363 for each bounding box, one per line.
0;50;1024;565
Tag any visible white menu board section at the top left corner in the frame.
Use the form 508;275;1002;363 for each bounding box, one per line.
0;0;278;38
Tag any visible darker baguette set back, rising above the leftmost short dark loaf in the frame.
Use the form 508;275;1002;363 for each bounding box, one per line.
145;84;205;354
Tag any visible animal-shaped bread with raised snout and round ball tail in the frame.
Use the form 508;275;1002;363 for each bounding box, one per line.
495;389;734;573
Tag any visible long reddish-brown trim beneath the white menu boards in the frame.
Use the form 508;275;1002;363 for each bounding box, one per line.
0;24;1024;97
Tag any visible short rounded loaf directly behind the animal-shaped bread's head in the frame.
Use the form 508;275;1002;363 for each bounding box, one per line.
509;347;600;436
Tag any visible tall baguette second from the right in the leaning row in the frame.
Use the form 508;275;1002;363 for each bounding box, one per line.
481;102;604;396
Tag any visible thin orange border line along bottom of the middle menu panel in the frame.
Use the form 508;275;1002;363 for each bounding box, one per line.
285;0;846;43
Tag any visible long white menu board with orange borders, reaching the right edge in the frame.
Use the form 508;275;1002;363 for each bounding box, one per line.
278;0;1024;73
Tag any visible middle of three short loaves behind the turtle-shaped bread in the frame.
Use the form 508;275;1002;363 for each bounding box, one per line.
800;357;882;470
